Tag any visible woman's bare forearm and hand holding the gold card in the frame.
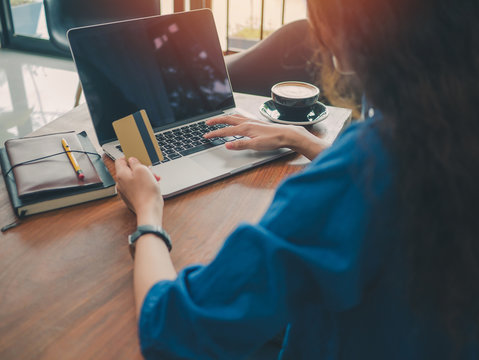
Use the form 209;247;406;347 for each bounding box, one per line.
115;158;176;317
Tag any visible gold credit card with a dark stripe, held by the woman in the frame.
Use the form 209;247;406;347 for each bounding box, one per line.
113;110;163;166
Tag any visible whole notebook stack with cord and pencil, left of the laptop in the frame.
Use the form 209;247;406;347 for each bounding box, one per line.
0;132;116;217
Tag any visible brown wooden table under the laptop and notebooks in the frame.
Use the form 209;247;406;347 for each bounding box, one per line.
0;94;350;360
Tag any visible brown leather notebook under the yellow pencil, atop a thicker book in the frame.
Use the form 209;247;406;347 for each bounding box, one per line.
5;132;102;198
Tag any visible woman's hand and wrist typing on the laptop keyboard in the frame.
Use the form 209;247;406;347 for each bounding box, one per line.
205;115;328;160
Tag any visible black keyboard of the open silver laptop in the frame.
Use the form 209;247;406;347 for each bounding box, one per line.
116;121;243;163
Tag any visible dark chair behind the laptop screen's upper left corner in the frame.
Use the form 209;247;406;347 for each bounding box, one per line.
43;0;161;107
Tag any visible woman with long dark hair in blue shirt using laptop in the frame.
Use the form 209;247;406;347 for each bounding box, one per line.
117;0;479;359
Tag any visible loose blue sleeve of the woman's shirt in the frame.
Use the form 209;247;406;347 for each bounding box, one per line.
139;120;394;359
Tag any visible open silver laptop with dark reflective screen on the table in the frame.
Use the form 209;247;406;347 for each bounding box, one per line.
68;9;291;197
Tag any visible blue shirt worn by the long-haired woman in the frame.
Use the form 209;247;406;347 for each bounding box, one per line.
139;111;474;359
